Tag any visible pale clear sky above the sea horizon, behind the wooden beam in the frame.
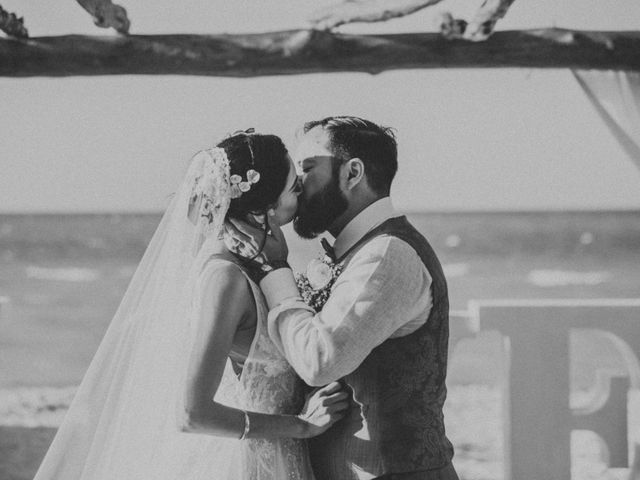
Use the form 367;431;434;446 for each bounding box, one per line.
0;0;640;213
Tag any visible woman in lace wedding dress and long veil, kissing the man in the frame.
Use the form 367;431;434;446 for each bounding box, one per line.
34;130;347;480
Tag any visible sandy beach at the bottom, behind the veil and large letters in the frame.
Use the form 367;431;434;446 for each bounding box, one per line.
0;385;640;480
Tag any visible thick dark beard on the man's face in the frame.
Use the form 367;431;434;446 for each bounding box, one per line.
293;175;349;239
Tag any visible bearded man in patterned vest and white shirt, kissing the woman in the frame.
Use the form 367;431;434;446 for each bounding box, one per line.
248;117;458;480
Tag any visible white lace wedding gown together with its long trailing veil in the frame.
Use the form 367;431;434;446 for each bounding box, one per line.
34;149;313;480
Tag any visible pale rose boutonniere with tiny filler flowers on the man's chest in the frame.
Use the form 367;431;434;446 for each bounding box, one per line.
296;255;342;312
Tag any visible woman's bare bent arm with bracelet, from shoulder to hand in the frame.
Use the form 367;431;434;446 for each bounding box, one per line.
178;263;347;438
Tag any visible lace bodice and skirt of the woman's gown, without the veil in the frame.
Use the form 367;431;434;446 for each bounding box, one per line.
198;257;314;480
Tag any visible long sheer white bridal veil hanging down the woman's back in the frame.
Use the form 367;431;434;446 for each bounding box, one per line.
34;149;248;480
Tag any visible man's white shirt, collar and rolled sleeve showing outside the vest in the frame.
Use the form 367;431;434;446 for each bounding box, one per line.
260;197;432;386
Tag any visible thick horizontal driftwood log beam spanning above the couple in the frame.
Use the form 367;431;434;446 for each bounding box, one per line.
0;29;640;77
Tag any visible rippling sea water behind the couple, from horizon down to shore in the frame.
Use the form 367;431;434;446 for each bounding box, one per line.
0;211;640;388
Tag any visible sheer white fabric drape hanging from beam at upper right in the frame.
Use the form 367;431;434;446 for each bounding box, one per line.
573;70;640;168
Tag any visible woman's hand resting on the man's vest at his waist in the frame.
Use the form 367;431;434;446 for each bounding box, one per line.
298;382;349;438
